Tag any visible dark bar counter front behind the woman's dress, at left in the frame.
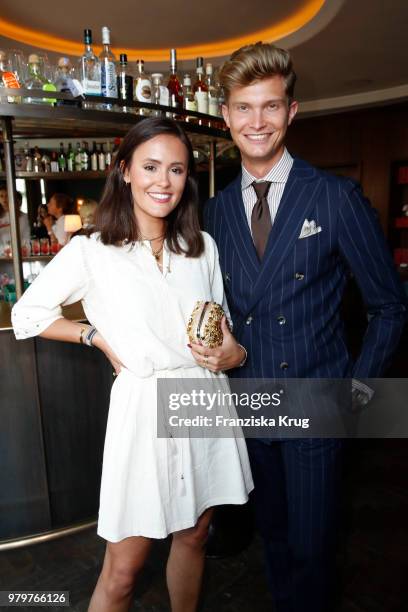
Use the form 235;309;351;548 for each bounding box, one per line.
0;302;113;546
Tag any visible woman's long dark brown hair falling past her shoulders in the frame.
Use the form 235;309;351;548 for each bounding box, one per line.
94;117;204;257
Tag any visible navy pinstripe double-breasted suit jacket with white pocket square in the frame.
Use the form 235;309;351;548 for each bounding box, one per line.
204;159;406;378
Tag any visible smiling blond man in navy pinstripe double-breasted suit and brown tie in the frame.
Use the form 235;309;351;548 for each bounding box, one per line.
193;43;406;612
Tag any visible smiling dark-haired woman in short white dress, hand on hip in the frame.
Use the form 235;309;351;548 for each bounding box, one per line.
12;119;253;612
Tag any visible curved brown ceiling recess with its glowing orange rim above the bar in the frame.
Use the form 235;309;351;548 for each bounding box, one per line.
0;0;327;61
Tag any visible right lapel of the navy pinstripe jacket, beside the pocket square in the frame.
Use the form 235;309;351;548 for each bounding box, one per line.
248;159;322;311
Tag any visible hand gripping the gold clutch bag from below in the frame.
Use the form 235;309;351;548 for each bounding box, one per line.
188;315;245;372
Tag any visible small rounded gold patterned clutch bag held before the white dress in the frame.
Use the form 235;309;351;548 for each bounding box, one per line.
187;302;224;348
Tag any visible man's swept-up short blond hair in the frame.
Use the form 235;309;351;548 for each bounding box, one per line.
219;42;296;102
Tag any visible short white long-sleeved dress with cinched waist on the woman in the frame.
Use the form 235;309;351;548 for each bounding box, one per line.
12;232;253;542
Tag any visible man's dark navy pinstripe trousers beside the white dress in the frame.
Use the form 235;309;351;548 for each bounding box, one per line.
247;438;342;612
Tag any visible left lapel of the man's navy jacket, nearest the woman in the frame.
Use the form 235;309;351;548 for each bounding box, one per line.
221;174;261;283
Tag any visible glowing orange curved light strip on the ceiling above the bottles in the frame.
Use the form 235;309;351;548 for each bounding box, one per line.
0;0;326;62
